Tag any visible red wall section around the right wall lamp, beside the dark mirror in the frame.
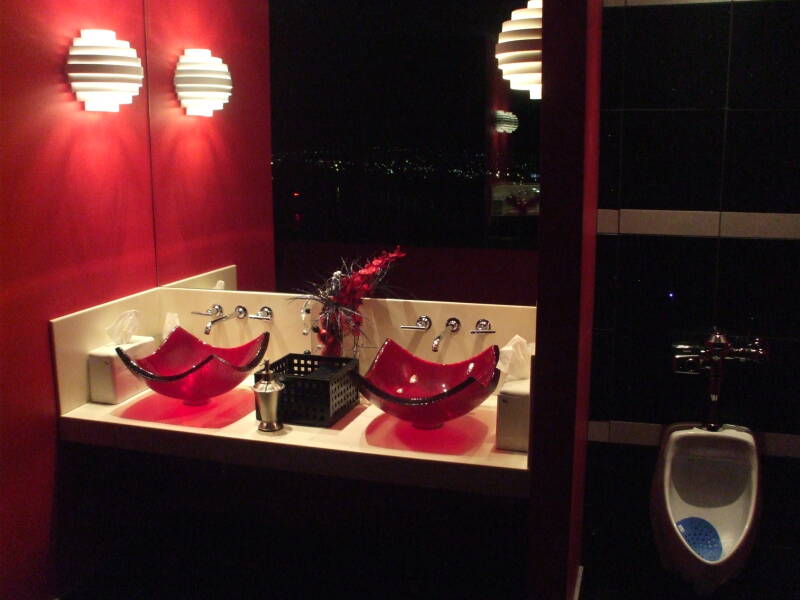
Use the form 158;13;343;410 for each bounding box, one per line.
147;0;275;290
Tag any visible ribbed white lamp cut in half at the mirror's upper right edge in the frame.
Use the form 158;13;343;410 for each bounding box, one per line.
495;0;542;100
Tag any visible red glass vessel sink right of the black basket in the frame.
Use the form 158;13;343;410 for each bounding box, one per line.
354;339;500;429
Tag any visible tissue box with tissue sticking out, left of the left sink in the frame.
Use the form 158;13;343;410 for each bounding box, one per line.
89;335;156;404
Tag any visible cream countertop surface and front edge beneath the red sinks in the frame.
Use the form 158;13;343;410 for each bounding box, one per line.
59;391;529;498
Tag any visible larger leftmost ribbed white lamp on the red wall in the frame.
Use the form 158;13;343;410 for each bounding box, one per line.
67;29;144;112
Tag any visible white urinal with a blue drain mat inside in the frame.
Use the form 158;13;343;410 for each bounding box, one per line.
650;424;759;594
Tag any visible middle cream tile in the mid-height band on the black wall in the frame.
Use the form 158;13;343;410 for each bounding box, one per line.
619;209;719;237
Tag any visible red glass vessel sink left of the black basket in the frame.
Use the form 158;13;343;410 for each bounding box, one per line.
116;327;269;404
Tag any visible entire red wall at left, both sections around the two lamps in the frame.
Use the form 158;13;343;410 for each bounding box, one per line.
0;0;274;599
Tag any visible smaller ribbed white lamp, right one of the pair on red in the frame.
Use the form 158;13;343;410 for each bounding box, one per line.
175;48;233;117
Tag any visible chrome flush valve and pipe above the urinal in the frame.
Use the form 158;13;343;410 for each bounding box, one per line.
672;327;768;431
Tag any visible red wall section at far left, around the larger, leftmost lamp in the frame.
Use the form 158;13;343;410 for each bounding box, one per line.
0;0;156;598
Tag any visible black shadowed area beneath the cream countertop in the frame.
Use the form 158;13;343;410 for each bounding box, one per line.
56;446;527;600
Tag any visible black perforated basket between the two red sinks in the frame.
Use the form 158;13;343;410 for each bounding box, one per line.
255;354;358;427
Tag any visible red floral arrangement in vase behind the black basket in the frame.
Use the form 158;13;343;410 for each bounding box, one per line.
305;246;405;356
